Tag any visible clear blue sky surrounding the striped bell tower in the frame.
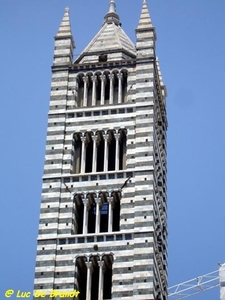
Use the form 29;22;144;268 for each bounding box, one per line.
0;0;225;300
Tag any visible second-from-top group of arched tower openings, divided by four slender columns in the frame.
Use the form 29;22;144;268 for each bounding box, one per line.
73;129;127;174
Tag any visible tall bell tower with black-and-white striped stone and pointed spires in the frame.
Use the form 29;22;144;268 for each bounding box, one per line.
34;0;167;300
